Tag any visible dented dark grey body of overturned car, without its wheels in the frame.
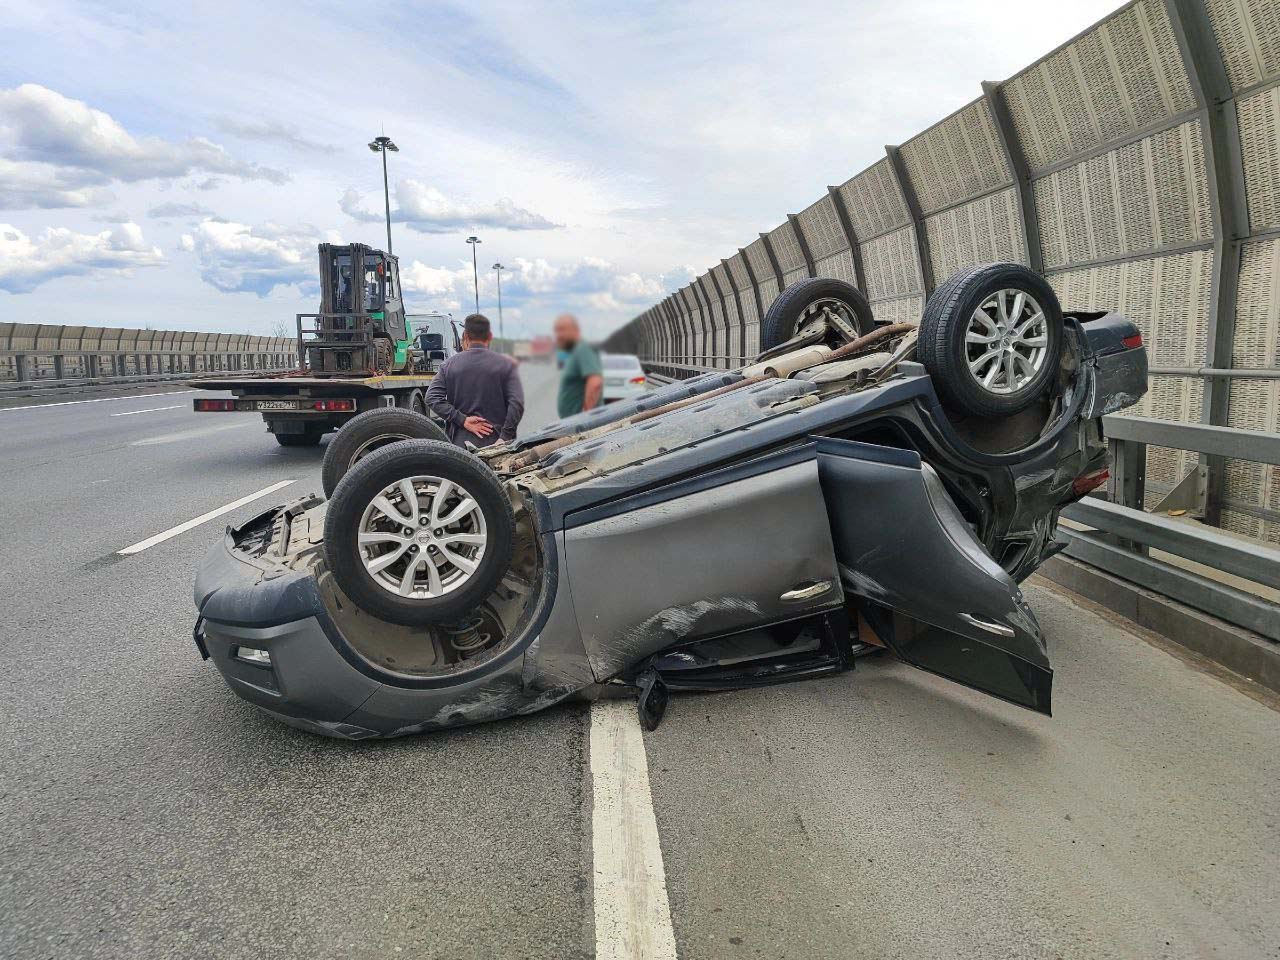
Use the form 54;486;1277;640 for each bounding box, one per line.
196;314;1147;739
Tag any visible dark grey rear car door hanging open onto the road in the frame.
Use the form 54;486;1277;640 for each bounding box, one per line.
818;439;1053;714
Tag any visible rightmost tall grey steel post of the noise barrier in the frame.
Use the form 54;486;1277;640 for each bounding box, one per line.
1165;0;1249;526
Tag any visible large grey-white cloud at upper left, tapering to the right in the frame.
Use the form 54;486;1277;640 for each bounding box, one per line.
0;83;288;209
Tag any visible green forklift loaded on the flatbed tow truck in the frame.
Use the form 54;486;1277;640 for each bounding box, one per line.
297;243;415;376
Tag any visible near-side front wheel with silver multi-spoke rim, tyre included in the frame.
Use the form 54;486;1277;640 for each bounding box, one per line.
324;440;515;626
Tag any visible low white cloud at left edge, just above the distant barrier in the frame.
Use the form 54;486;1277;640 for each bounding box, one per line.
0;223;164;293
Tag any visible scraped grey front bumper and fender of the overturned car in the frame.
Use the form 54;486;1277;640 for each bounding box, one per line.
195;515;594;740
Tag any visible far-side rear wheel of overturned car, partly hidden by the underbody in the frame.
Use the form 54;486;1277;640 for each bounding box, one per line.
760;276;874;358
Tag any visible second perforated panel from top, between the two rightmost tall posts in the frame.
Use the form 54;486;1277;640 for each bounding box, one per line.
1033;120;1213;269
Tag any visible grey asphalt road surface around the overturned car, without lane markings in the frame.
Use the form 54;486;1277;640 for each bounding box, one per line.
0;367;1280;960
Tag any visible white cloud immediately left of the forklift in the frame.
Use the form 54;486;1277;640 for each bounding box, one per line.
182;220;328;297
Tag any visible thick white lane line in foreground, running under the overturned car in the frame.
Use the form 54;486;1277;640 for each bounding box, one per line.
591;700;676;960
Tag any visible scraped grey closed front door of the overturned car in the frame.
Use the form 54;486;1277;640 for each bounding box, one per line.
564;444;844;681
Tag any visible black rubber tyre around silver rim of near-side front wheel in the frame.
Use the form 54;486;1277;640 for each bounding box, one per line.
324;440;515;626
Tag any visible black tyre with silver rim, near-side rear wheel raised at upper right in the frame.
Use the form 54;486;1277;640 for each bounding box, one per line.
916;264;1062;417
